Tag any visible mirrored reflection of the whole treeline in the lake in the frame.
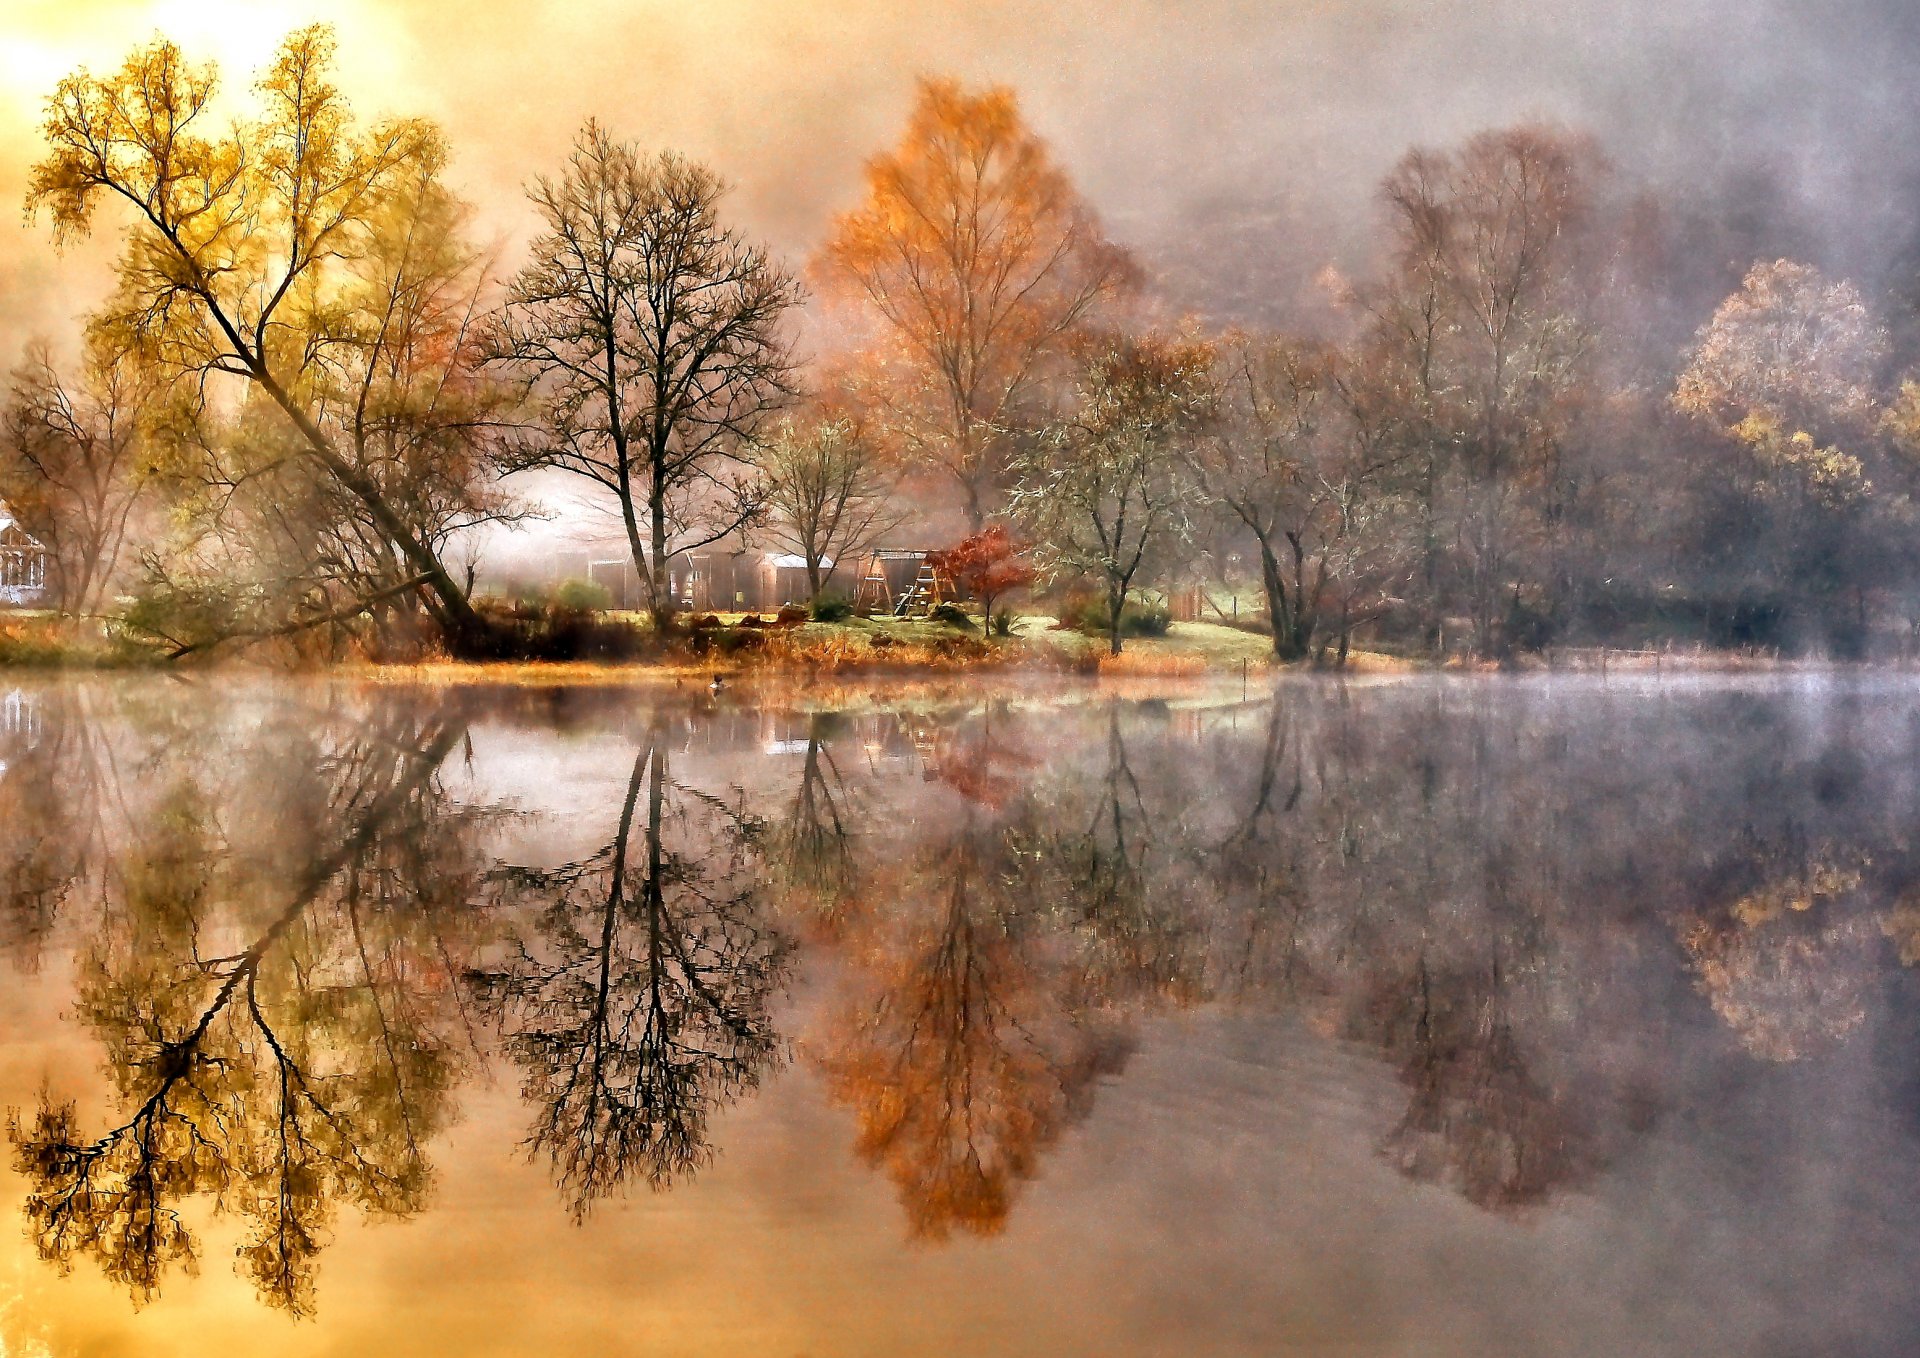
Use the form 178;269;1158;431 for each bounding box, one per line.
0;684;1920;1344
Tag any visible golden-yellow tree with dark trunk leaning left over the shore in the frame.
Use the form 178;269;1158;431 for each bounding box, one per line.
27;25;486;649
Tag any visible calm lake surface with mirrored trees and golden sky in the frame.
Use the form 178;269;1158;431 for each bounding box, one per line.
0;678;1920;1358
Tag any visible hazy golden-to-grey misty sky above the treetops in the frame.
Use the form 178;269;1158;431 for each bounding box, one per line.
0;0;1920;572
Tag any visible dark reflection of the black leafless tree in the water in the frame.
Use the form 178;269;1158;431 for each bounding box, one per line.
472;741;787;1216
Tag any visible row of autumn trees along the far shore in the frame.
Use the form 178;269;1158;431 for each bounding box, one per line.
0;27;1920;659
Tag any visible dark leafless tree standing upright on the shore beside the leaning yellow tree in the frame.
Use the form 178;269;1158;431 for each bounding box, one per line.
493;121;801;624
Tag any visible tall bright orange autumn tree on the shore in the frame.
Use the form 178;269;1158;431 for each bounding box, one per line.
814;72;1137;532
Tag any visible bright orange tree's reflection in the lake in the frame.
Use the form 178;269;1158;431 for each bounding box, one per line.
818;811;1127;1239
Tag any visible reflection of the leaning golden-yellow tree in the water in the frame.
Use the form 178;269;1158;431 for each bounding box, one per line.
8;718;476;1314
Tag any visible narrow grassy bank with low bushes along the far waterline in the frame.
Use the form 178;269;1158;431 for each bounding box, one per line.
11;592;1832;680
